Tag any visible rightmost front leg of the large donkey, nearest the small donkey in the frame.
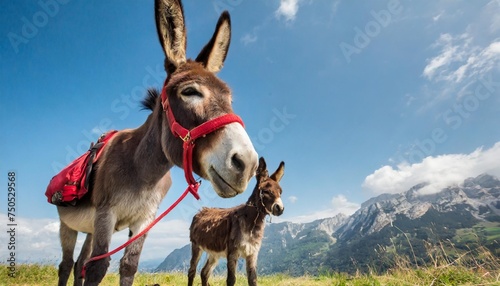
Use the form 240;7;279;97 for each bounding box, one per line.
120;221;150;286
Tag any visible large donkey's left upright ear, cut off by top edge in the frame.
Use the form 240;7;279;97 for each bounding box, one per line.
155;0;186;73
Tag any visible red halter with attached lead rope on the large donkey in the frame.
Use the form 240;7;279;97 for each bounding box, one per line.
81;78;244;278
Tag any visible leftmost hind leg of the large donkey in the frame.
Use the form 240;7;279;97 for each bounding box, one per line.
58;221;78;286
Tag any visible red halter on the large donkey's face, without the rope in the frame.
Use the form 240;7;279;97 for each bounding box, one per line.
161;77;245;200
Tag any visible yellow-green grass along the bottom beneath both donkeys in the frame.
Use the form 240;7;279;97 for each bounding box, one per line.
0;238;500;286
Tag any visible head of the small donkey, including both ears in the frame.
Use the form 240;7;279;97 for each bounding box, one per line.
254;157;285;216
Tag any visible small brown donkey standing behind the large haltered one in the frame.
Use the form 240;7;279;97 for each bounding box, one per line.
188;157;285;286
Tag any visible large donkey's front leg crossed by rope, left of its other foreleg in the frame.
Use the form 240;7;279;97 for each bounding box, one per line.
83;208;116;286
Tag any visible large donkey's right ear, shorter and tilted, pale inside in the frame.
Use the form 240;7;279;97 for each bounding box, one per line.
196;11;231;73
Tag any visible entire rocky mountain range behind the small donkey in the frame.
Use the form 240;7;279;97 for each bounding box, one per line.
156;174;500;275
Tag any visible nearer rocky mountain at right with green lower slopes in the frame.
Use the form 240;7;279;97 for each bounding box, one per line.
325;174;500;272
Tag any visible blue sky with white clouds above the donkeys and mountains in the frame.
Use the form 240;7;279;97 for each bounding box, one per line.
0;0;500;266
